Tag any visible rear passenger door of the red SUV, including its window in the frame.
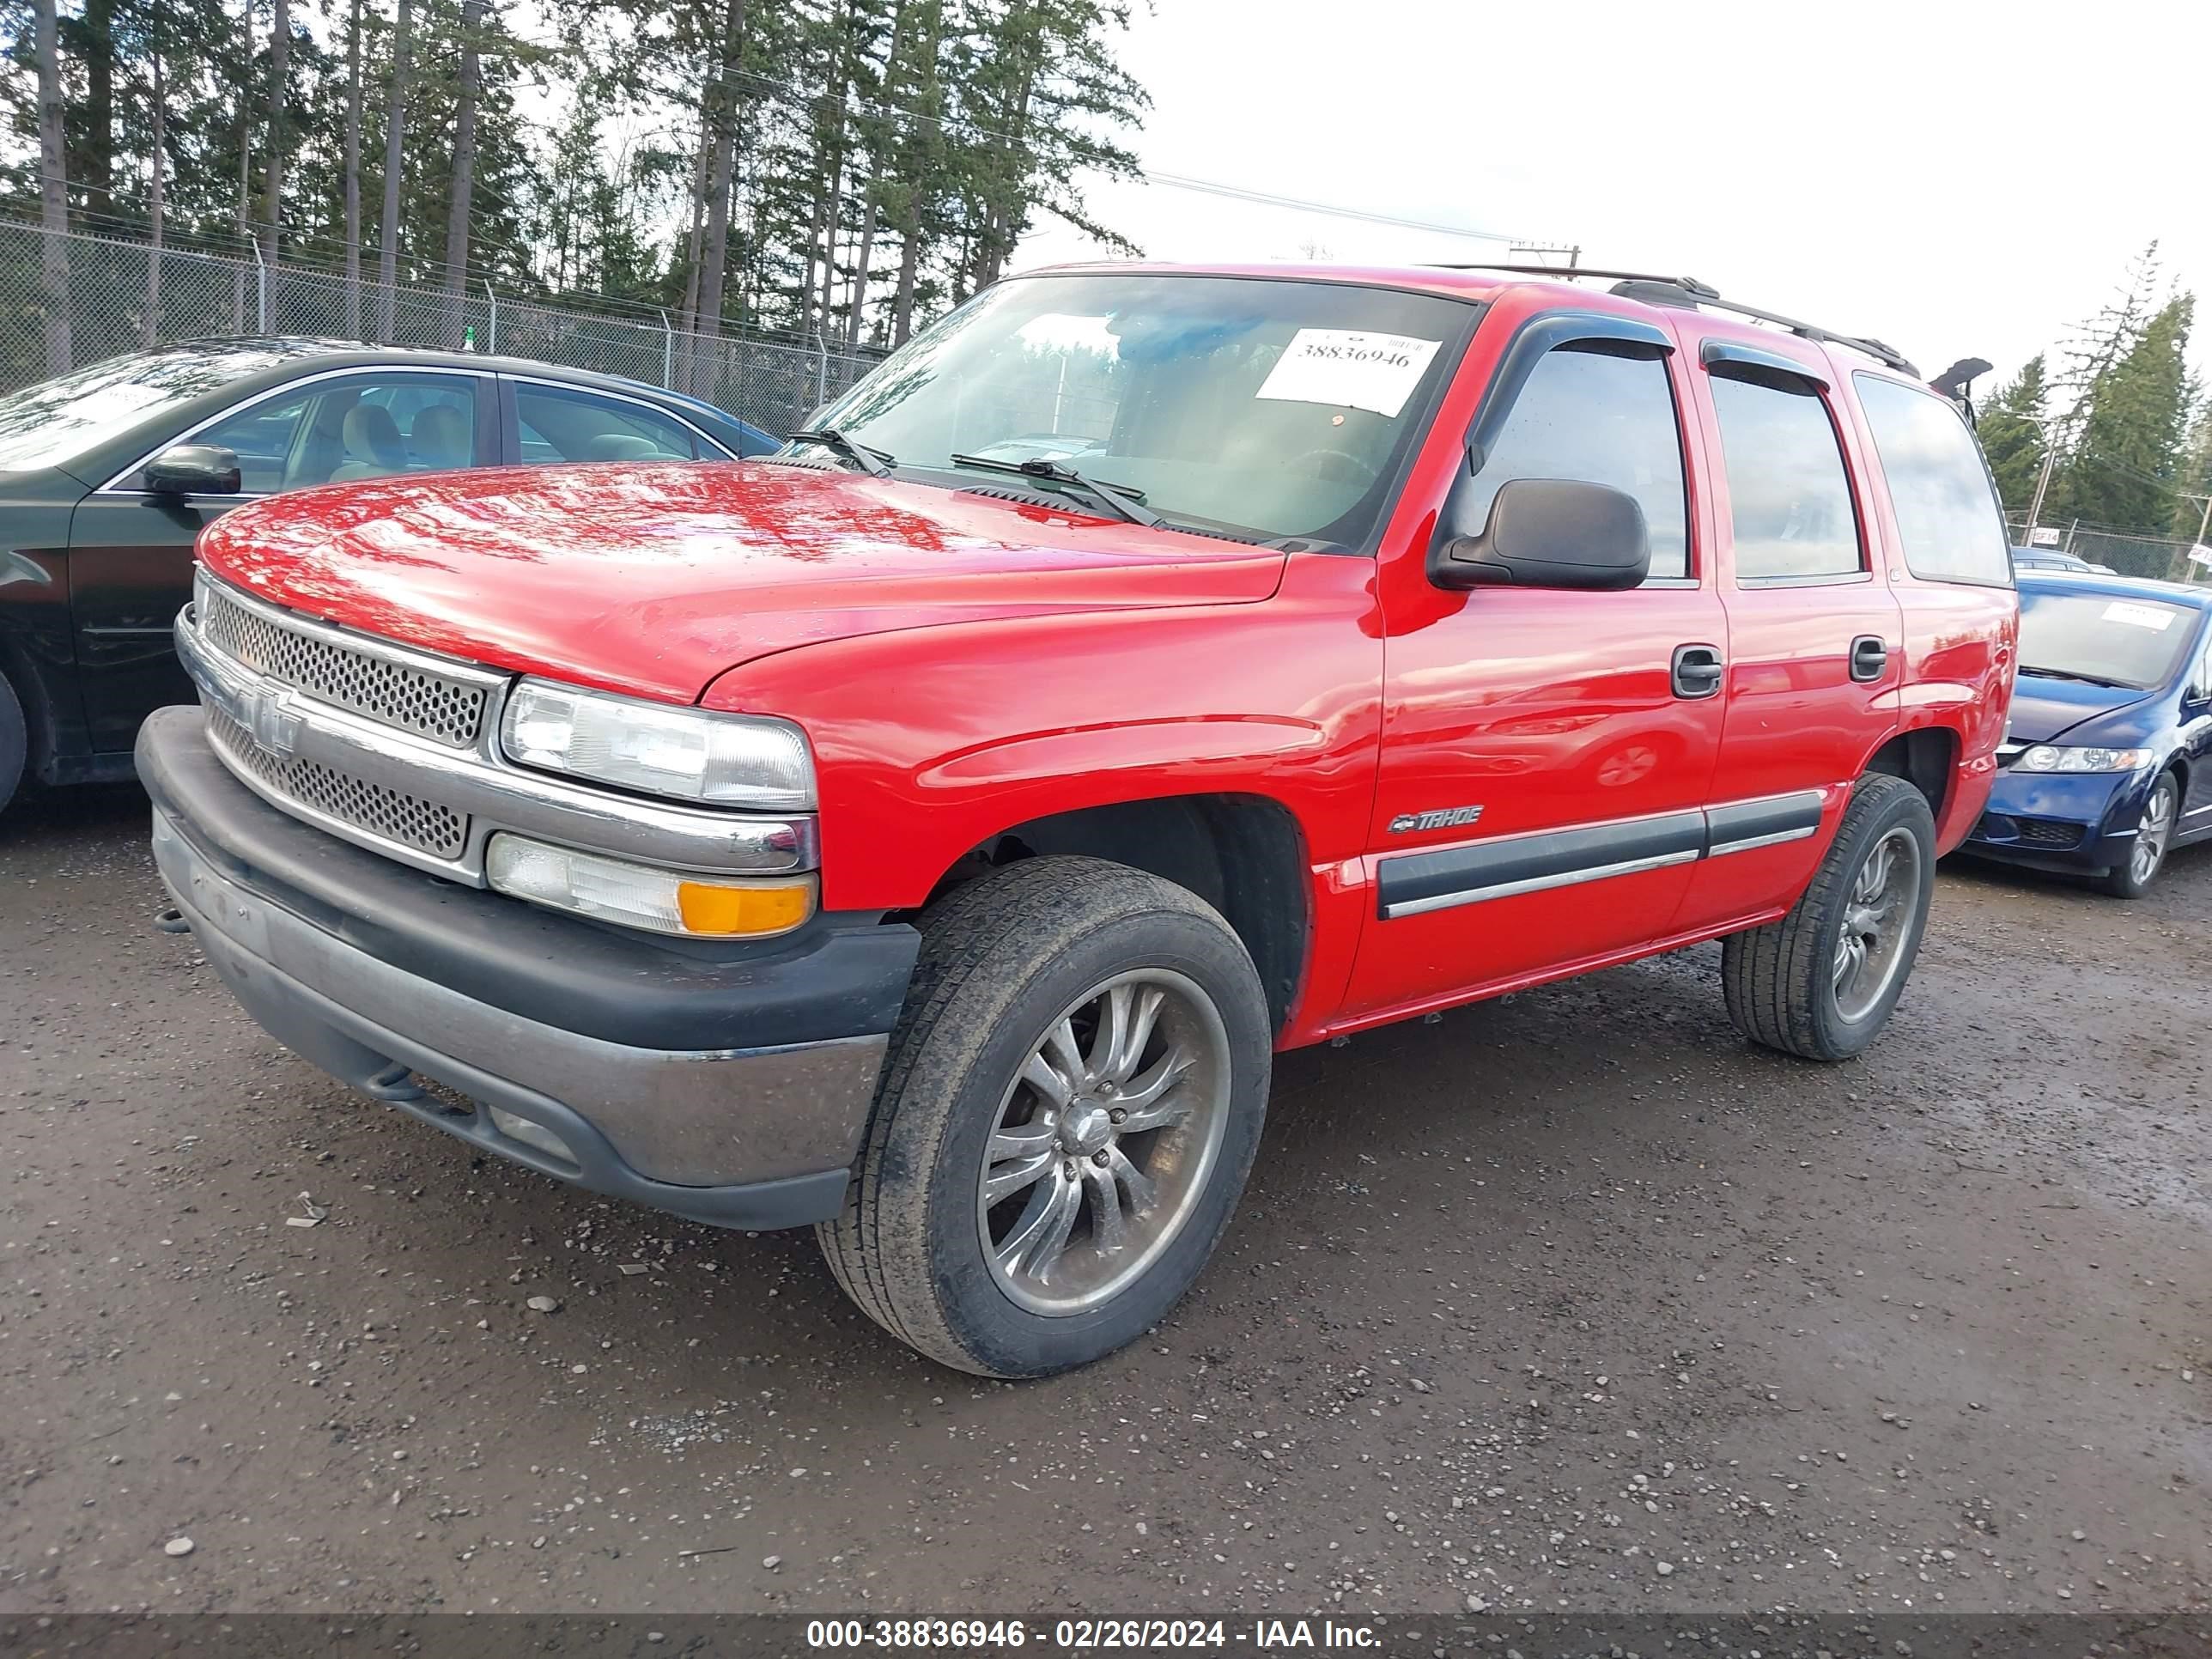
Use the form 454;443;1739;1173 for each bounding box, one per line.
1681;337;1905;929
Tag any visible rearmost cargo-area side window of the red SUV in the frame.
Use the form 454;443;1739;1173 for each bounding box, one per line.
1851;374;2017;586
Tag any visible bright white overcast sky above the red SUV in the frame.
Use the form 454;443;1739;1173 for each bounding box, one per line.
1018;0;2212;394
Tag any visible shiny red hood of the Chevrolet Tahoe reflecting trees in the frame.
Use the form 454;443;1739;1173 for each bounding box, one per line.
199;462;1283;703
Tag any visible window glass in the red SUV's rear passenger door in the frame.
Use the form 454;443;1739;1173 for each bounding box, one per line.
1708;362;1865;581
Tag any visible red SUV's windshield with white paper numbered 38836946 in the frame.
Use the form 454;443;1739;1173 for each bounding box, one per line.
796;274;1475;546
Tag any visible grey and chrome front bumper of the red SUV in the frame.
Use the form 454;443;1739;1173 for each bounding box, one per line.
137;708;921;1228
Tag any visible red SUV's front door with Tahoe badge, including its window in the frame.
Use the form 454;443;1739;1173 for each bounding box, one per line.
1347;314;1728;1018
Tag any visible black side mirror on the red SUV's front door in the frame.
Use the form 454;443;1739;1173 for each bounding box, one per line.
1429;473;1652;591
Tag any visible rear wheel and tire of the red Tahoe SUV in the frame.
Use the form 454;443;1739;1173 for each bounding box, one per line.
1721;772;1936;1060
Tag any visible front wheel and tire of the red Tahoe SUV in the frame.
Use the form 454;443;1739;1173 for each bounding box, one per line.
817;858;1274;1378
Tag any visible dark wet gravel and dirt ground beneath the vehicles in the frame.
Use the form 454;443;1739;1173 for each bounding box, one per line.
0;790;2212;1613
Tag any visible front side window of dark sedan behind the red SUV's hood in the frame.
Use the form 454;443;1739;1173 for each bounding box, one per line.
192;374;476;495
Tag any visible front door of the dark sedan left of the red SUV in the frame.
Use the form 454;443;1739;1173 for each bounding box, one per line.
69;368;498;752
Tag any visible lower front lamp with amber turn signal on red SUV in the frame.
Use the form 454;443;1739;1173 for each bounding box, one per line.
484;834;814;938
